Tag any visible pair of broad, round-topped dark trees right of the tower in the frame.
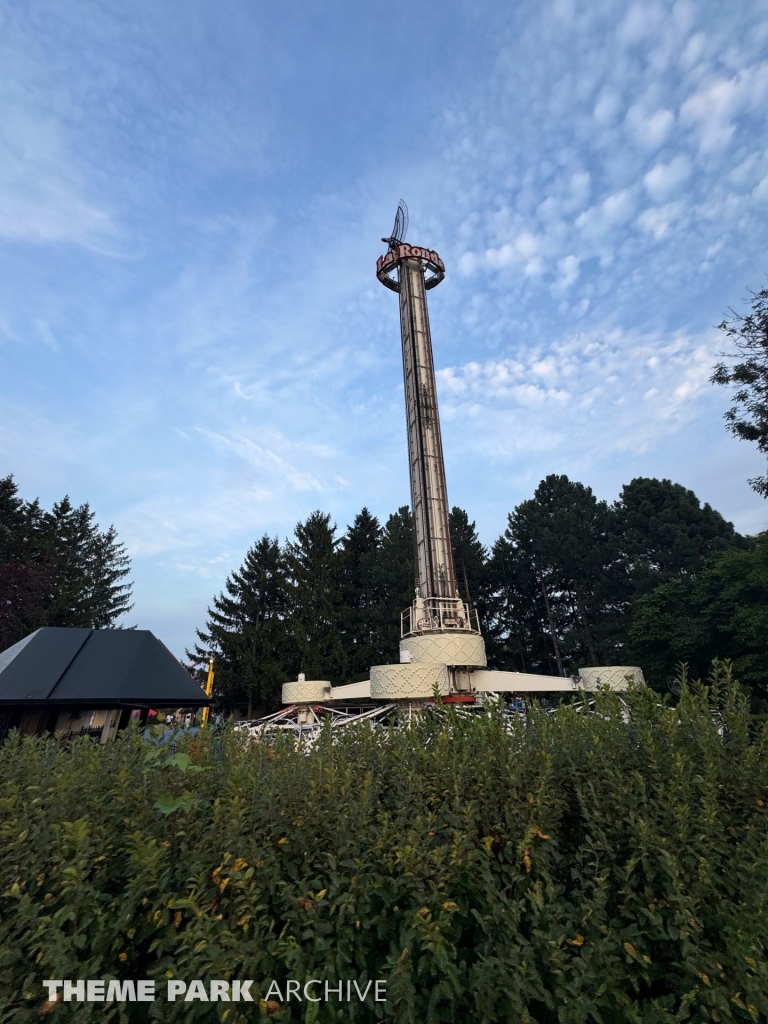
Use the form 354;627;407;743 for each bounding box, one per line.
485;475;763;686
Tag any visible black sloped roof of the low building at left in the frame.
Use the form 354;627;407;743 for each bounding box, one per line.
0;627;213;708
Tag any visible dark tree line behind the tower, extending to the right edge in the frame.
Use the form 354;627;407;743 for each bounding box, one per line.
193;475;768;714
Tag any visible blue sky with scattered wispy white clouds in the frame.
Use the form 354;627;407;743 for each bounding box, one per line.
0;0;768;656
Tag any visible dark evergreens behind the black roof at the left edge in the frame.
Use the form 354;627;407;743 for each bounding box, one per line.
0;476;132;650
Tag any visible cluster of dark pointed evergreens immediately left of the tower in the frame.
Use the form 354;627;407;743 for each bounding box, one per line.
187;507;414;718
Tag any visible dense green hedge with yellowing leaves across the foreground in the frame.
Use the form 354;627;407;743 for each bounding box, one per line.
0;664;768;1024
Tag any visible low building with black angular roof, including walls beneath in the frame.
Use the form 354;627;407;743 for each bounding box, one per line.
0;627;214;742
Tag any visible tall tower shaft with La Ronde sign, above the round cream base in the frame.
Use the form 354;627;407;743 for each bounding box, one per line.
376;203;476;635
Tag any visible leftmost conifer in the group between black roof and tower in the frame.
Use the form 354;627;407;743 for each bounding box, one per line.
187;534;290;718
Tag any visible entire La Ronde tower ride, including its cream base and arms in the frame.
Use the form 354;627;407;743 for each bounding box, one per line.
270;203;643;726
